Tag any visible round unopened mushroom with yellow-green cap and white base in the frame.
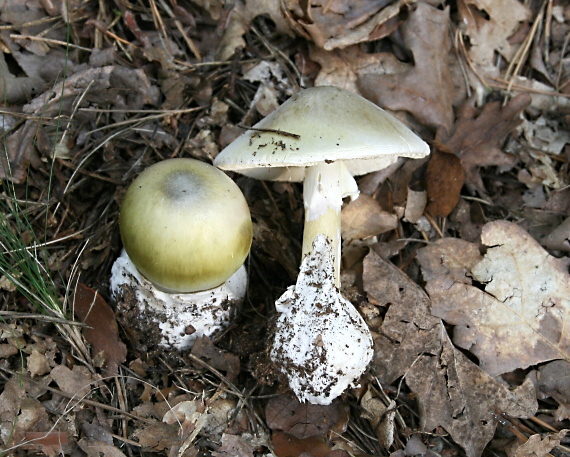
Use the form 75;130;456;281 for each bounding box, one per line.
111;159;252;350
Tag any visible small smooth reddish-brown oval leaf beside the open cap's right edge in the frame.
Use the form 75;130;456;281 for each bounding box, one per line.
425;149;465;217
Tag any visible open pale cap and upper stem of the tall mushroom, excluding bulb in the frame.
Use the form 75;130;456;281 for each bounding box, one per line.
214;86;429;286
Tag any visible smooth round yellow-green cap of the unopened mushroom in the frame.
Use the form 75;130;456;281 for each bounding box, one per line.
119;159;252;293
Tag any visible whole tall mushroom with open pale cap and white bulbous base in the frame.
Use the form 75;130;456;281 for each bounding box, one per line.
214;86;429;404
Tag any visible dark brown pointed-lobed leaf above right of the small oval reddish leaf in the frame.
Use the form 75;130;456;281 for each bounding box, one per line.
439;93;530;196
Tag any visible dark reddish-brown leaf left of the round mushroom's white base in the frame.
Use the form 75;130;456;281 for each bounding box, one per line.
74;284;127;376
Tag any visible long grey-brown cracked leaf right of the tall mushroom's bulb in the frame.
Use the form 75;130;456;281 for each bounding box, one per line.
363;251;537;457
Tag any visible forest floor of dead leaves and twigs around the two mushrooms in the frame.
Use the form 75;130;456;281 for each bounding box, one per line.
0;0;570;457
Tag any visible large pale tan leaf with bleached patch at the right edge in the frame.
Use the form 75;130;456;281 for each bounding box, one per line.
418;221;570;376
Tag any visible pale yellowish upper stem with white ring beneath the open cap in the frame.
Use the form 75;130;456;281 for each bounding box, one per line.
303;160;358;287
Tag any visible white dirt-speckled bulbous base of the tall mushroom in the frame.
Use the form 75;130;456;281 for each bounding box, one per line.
270;235;372;405
